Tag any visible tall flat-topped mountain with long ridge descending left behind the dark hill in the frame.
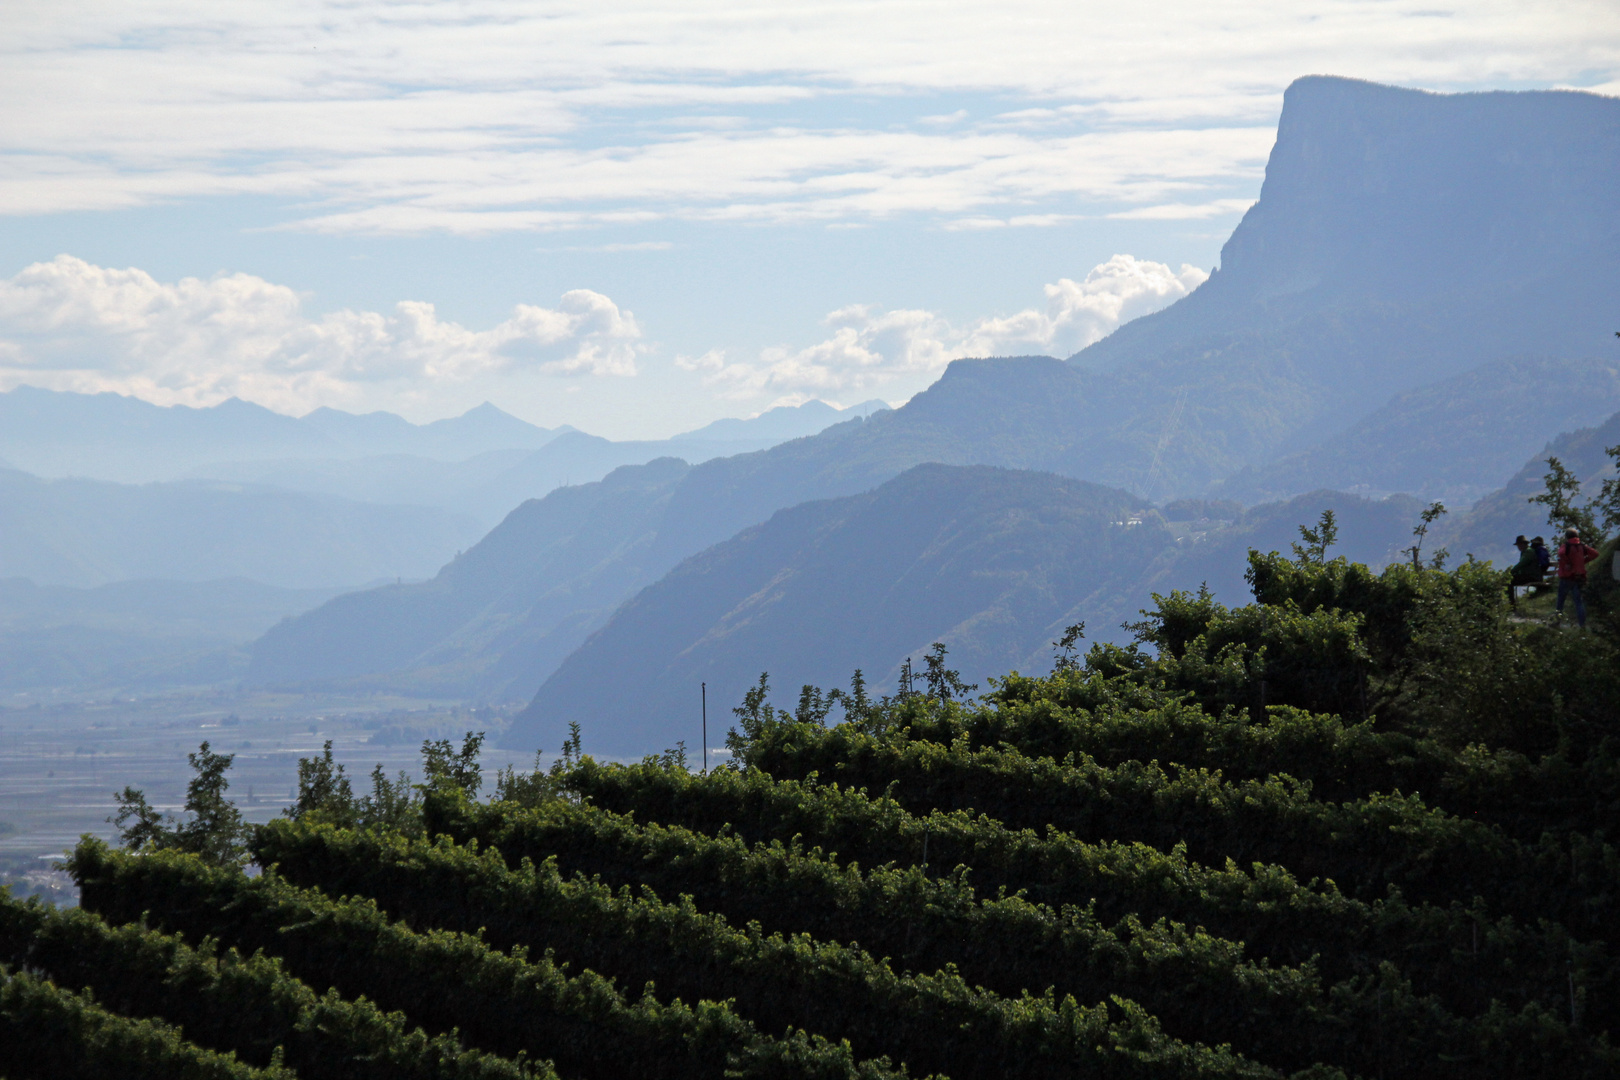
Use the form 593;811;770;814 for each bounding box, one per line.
239;78;1620;709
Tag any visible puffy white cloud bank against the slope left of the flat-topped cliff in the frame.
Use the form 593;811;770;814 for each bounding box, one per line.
690;254;1209;398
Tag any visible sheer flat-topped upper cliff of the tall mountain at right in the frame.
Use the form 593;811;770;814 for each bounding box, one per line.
1221;76;1620;304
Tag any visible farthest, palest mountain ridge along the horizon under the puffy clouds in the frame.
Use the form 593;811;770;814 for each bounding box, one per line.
0;387;888;529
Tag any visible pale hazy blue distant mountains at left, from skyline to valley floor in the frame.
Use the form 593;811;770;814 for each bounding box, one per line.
0;396;886;690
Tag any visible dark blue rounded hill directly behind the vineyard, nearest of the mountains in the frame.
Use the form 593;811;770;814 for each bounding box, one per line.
502;465;1419;756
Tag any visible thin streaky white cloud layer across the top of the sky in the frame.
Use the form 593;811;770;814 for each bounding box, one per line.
0;0;1620;233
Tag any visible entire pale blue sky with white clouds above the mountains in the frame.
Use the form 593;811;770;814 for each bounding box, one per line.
0;0;1620;439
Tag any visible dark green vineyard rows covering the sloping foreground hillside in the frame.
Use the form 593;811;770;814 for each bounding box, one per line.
0;552;1620;1080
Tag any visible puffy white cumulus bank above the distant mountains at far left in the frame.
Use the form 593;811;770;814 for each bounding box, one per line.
0;256;643;411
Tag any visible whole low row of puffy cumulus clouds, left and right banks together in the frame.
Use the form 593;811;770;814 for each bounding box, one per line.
0;254;1209;413
